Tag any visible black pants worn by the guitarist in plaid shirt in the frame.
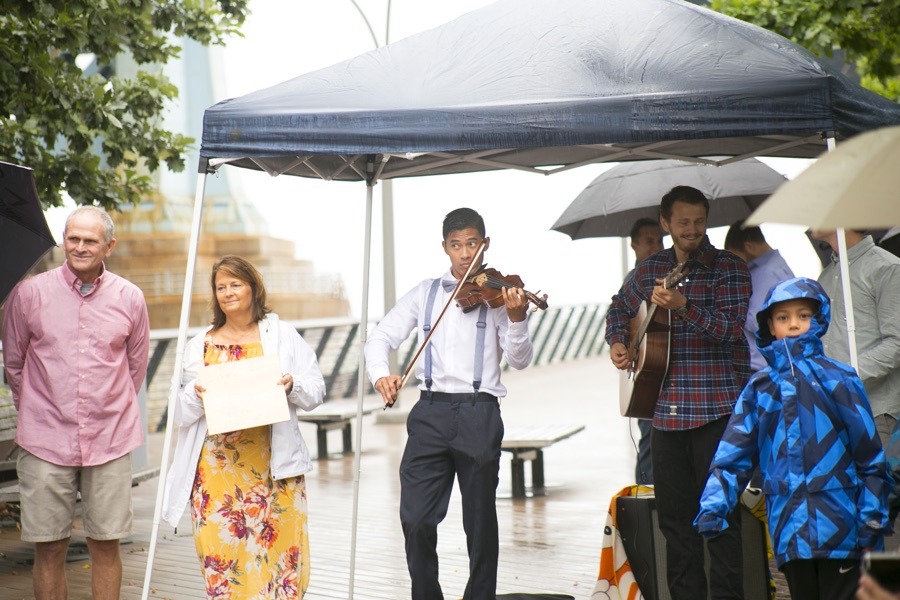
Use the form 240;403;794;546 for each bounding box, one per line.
650;417;744;600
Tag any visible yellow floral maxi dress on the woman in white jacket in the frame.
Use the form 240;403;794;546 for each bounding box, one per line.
191;337;309;600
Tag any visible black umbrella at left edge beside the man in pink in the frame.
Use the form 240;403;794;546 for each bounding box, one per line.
0;162;56;305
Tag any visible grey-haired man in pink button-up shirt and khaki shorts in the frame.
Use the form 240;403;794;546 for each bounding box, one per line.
3;206;150;600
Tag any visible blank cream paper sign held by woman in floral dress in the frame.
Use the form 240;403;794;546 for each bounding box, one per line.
198;355;290;434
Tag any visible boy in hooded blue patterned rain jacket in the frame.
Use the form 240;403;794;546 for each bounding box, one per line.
694;277;891;600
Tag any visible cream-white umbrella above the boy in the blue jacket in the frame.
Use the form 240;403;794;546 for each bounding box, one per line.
747;127;900;229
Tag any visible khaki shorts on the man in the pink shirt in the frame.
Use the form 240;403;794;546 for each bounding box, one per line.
16;448;132;542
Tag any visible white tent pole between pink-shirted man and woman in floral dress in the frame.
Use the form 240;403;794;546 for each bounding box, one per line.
141;168;206;600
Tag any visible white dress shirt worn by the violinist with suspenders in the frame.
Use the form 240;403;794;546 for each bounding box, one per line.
365;271;534;398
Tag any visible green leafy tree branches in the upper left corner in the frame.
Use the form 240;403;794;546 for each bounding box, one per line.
0;0;248;209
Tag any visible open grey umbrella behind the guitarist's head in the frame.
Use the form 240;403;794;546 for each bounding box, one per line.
552;158;787;240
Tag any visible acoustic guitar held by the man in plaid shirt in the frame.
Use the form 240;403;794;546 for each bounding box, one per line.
619;263;687;419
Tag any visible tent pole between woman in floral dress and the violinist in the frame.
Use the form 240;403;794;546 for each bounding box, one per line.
347;165;375;600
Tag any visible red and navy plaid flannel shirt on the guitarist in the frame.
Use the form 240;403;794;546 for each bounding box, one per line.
606;238;751;431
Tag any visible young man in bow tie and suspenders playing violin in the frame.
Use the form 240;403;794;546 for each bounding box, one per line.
365;208;533;600
